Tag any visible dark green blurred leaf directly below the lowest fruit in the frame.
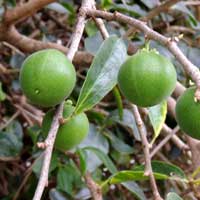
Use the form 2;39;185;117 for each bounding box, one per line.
57;163;82;195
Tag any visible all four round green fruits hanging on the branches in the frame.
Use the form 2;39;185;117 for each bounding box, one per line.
20;49;200;151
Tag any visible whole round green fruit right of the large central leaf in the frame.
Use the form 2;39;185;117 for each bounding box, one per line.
118;50;177;107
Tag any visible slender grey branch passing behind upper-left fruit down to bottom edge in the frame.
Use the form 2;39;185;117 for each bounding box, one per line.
33;0;93;200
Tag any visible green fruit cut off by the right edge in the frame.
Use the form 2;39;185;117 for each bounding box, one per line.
176;87;200;140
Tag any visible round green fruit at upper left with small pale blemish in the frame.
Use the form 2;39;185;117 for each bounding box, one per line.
19;49;76;107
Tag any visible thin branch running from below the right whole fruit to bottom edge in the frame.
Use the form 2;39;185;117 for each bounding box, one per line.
132;105;162;200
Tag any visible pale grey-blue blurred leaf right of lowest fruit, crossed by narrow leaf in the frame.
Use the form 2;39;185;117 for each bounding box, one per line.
78;124;109;172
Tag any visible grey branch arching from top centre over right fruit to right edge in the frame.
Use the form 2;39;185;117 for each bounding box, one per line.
86;9;200;100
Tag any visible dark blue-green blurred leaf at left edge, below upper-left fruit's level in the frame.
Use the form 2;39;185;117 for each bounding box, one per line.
0;121;23;158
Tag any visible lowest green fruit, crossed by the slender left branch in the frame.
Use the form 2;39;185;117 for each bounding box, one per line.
42;105;89;151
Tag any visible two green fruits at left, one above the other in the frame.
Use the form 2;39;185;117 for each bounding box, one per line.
20;49;89;151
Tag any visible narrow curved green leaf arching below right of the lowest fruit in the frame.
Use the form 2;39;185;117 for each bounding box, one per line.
84;147;117;173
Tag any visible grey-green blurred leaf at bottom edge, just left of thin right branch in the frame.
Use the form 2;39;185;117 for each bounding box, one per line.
121;181;146;200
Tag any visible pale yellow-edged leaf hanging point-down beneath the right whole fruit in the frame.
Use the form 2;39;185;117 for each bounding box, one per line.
148;101;167;144
